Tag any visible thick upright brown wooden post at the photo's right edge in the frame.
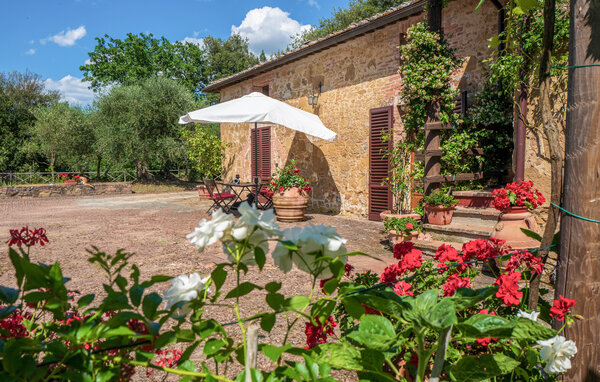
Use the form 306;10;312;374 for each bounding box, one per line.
555;0;600;381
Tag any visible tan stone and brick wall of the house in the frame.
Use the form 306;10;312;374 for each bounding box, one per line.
221;0;497;216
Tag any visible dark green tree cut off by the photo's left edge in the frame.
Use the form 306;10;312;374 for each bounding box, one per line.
0;71;59;171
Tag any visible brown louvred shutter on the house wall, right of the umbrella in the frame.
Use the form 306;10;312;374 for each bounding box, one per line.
369;106;394;221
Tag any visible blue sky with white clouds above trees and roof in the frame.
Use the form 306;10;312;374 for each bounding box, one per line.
0;0;348;105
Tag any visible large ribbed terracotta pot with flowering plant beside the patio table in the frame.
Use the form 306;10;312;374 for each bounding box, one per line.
267;159;311;222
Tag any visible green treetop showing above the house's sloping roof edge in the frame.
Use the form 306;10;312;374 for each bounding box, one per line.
289;0;405;49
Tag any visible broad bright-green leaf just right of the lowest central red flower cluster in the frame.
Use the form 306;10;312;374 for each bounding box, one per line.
348;315;396;352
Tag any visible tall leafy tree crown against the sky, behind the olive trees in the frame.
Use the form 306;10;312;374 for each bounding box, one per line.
79;33;207;94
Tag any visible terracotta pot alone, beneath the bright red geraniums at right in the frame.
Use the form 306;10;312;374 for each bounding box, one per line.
492;206;540;249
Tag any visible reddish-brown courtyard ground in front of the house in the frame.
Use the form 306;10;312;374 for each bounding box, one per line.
0;192;404;379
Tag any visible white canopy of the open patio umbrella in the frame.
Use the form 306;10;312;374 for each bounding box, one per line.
179;92;337;142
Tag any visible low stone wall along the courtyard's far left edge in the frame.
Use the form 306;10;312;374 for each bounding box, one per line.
0;183;132;199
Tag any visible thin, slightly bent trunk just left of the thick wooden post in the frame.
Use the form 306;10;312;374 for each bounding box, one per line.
528;0;564;310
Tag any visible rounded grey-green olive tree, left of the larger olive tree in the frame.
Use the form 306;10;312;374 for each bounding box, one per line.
26;102;94;177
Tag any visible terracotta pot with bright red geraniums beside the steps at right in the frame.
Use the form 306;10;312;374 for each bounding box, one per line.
492;181;546;249
